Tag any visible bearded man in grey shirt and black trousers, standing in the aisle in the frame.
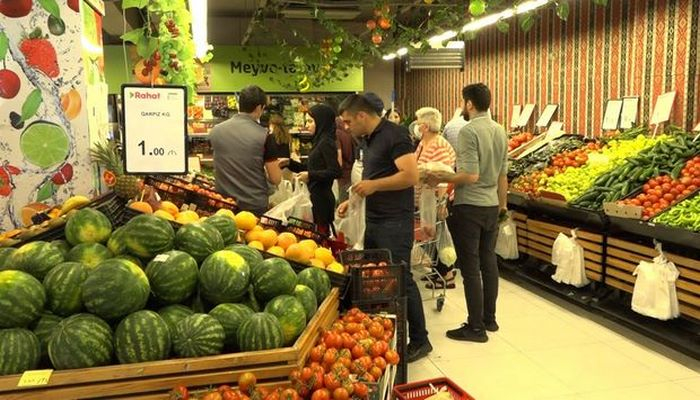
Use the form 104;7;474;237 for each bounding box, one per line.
429;83;508;343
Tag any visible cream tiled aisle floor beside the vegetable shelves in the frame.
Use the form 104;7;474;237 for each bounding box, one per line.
409;278;700;400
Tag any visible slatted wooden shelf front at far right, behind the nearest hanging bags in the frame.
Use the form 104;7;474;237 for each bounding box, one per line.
605;237;700;320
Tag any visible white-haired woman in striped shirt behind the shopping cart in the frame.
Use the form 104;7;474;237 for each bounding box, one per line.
412;107;457;289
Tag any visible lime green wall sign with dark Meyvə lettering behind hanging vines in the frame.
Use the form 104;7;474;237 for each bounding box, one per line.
104;46;363;93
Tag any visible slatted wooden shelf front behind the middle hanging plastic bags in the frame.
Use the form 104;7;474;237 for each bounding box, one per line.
525;218;605;282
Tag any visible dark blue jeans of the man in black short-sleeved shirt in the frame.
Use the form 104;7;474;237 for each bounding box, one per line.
365;215;428;344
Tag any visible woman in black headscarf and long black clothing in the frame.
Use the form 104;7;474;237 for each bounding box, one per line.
282;104;342;233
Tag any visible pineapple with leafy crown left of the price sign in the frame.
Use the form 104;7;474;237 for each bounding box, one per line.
90;141;142;199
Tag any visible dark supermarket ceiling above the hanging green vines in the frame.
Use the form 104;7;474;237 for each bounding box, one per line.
98;0;464;45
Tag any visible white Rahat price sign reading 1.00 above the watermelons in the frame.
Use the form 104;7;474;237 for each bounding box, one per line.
122;85;187;175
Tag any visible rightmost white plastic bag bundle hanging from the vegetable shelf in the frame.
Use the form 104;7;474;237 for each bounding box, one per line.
632;248;680;320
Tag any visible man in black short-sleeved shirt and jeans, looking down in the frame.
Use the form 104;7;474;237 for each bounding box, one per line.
338;95;433;362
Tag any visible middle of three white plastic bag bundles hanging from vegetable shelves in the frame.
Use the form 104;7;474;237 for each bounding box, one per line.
552;230;589;287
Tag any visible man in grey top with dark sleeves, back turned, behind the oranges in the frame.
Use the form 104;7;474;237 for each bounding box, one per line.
209;86;282;216
